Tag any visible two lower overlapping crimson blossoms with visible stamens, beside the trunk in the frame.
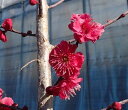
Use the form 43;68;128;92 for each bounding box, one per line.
46;41;84;99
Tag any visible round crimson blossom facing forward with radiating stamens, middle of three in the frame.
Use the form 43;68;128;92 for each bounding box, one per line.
49;41;84;78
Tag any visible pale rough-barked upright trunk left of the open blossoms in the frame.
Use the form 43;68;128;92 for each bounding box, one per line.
37;0;52;110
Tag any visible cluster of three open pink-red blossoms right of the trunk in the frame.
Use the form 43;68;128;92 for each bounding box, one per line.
46;14;104;99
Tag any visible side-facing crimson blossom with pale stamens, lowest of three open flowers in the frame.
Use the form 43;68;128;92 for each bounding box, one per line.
46;77;82;99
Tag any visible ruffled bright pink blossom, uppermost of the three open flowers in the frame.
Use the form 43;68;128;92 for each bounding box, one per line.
68;14;104;43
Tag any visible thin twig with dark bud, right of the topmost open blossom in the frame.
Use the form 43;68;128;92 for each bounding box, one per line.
104;11;128;27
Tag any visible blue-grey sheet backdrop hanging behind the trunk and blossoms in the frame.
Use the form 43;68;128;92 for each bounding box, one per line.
0;0;128;110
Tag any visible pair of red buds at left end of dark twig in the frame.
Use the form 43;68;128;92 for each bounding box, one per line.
0;18;13;42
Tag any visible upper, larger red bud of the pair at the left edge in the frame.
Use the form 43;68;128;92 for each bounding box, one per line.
2;18;13;31
